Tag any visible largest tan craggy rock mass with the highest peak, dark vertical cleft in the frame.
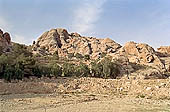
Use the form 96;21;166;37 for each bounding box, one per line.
33;28;121;58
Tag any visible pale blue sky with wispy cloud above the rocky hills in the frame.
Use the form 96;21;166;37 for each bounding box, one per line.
0;0;170;48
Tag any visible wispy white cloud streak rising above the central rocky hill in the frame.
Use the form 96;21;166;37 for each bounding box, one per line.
72;0;107;34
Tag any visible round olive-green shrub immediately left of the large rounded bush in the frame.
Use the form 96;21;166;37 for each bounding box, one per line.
75;63;90;77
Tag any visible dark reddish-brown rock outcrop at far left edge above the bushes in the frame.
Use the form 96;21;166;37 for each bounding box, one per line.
0;29;11;52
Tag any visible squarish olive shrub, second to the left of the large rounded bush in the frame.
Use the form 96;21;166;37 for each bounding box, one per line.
62;63;75;77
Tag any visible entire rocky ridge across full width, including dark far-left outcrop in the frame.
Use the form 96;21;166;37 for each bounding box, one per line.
0;28;170;77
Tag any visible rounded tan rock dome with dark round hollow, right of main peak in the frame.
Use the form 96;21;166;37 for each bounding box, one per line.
120;42;165;70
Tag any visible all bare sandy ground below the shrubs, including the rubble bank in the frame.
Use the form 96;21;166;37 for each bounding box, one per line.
0;78;170;112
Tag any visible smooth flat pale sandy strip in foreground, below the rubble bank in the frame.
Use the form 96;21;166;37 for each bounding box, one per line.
0;94;170;112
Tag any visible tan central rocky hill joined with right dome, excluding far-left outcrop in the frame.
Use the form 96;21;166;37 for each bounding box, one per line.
32;28;167;71
